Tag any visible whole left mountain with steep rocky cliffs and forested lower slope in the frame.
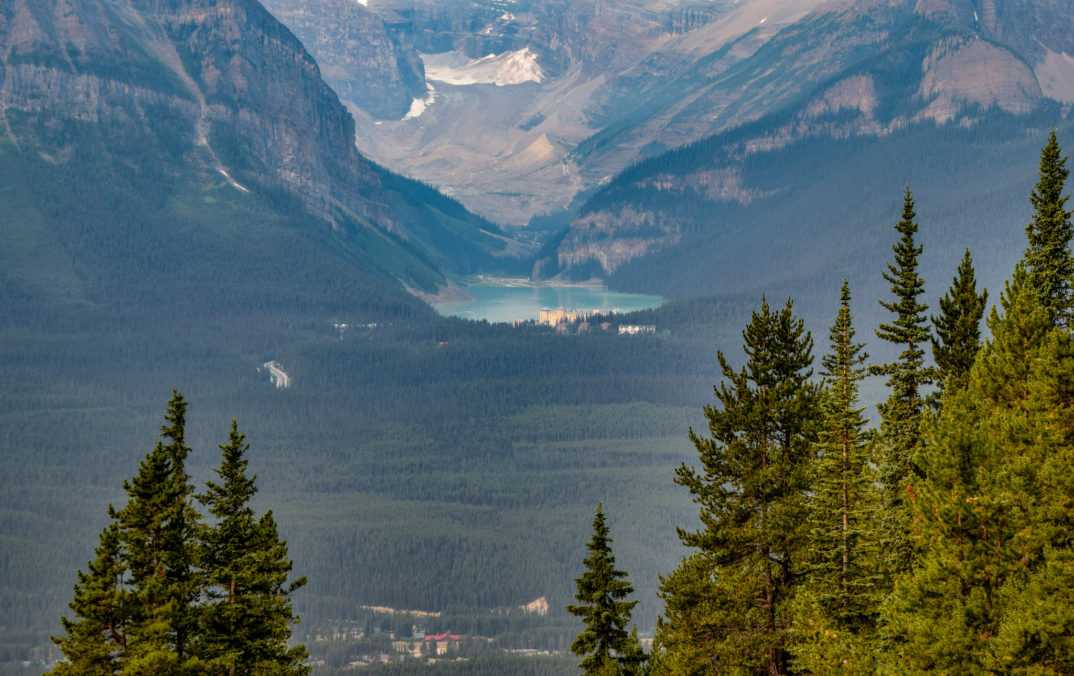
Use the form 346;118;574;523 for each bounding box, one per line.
0;0;519;311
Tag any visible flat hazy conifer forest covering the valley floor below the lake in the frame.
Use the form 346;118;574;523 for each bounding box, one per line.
0;296;721;660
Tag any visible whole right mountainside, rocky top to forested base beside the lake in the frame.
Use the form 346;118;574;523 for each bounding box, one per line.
534;3;1074;322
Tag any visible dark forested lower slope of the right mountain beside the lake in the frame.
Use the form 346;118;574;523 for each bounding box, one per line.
545;112;1071;301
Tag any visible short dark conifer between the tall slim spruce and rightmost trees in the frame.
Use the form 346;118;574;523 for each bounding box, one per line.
932;249;988;400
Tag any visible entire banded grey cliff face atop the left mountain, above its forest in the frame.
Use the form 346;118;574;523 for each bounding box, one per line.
0;0;394;229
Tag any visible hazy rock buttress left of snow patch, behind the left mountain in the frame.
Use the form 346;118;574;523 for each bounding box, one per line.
257;0;425;119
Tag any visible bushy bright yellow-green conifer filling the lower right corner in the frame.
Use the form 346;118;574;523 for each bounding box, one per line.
883;265;1074;674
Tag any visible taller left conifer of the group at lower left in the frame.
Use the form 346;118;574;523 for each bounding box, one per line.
54;391;199;674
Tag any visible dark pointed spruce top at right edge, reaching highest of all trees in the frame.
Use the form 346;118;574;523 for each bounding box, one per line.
1024;129;1074;327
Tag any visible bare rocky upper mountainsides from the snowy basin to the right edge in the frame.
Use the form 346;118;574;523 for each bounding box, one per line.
266;0;1074;225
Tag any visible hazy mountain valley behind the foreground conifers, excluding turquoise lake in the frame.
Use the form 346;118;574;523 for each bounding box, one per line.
6;0;1074;675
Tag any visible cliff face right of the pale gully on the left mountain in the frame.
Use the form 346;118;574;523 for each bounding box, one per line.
133;0;401;231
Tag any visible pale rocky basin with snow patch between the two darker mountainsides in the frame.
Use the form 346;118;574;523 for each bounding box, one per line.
262;0;695;225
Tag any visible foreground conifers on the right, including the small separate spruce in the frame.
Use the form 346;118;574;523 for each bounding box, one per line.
568;131;1074;675
